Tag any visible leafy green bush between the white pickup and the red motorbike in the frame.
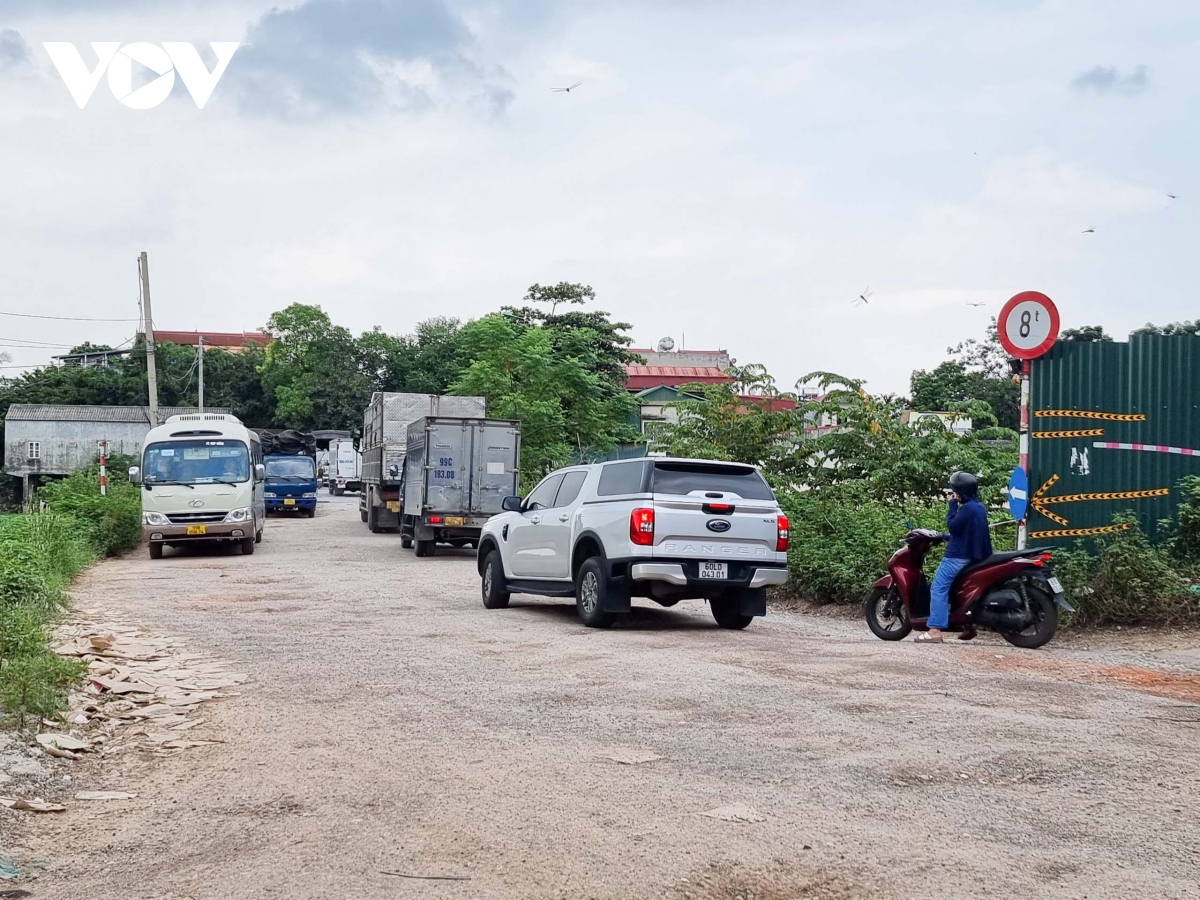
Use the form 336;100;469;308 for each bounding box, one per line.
776;484;946;604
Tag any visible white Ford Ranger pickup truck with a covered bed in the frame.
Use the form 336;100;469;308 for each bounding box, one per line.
478;458;788;629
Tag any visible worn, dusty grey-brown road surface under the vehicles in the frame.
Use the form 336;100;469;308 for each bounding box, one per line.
2;497;1200;900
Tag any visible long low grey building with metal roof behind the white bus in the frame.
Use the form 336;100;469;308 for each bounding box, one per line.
4;403;232;502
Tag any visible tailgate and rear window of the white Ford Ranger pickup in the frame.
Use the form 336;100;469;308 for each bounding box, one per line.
650;460;779;563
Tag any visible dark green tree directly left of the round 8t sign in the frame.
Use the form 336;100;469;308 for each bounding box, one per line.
910;319;1021;431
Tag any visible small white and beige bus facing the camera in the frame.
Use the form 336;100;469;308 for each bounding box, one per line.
130;413;266;559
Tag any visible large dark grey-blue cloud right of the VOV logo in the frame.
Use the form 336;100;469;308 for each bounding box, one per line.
229;0;512;119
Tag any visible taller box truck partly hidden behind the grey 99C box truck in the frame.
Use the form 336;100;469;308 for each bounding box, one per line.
359;391;487;533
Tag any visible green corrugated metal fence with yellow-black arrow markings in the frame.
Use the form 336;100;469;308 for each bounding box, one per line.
1028;335;1200;544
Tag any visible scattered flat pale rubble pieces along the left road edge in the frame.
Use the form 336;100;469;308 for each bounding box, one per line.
0;610;246;812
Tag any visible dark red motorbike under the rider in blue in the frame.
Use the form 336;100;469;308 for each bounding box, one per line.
866;528;1073;648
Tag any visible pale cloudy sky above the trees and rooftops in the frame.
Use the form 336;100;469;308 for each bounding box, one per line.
0;0;1200;391
